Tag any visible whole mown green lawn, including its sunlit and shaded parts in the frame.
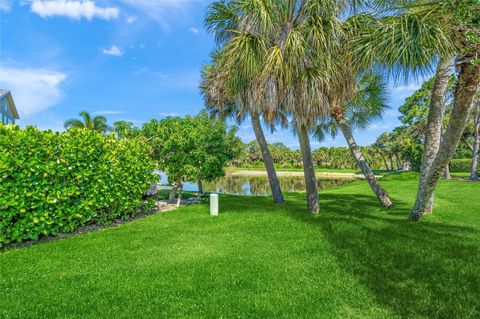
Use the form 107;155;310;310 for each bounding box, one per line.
0;173;480;318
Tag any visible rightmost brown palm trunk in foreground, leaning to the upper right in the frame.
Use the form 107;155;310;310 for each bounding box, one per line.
410;56;480;220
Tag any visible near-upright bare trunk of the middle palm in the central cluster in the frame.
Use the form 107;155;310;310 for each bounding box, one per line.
297;125;320;214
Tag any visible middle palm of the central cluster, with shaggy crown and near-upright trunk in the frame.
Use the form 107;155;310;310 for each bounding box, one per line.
206;0;337;213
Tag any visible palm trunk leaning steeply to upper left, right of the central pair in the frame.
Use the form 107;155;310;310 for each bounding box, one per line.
334;112;392;208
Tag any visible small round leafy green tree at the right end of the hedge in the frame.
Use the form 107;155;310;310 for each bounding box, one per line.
141;111;238;205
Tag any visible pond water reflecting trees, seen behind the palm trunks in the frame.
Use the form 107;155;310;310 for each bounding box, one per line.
160;174;354;196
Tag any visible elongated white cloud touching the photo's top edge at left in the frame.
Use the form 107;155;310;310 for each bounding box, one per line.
30;0;119;20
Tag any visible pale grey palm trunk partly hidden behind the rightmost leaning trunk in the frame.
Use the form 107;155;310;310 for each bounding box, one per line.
412;58;453;218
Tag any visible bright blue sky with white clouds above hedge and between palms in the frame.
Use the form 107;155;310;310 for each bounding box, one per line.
0;0;419;148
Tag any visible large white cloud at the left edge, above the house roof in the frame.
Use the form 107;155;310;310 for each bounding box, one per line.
0;65;67;117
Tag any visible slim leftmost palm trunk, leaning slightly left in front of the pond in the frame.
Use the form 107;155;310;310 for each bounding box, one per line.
250;113;284;204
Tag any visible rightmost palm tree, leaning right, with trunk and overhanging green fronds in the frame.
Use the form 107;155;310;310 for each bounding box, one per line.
354;0;480;220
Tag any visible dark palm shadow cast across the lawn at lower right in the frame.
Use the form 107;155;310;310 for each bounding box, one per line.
284;193;480;318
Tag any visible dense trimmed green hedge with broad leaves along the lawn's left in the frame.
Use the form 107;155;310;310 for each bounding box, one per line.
0;125;155;247
